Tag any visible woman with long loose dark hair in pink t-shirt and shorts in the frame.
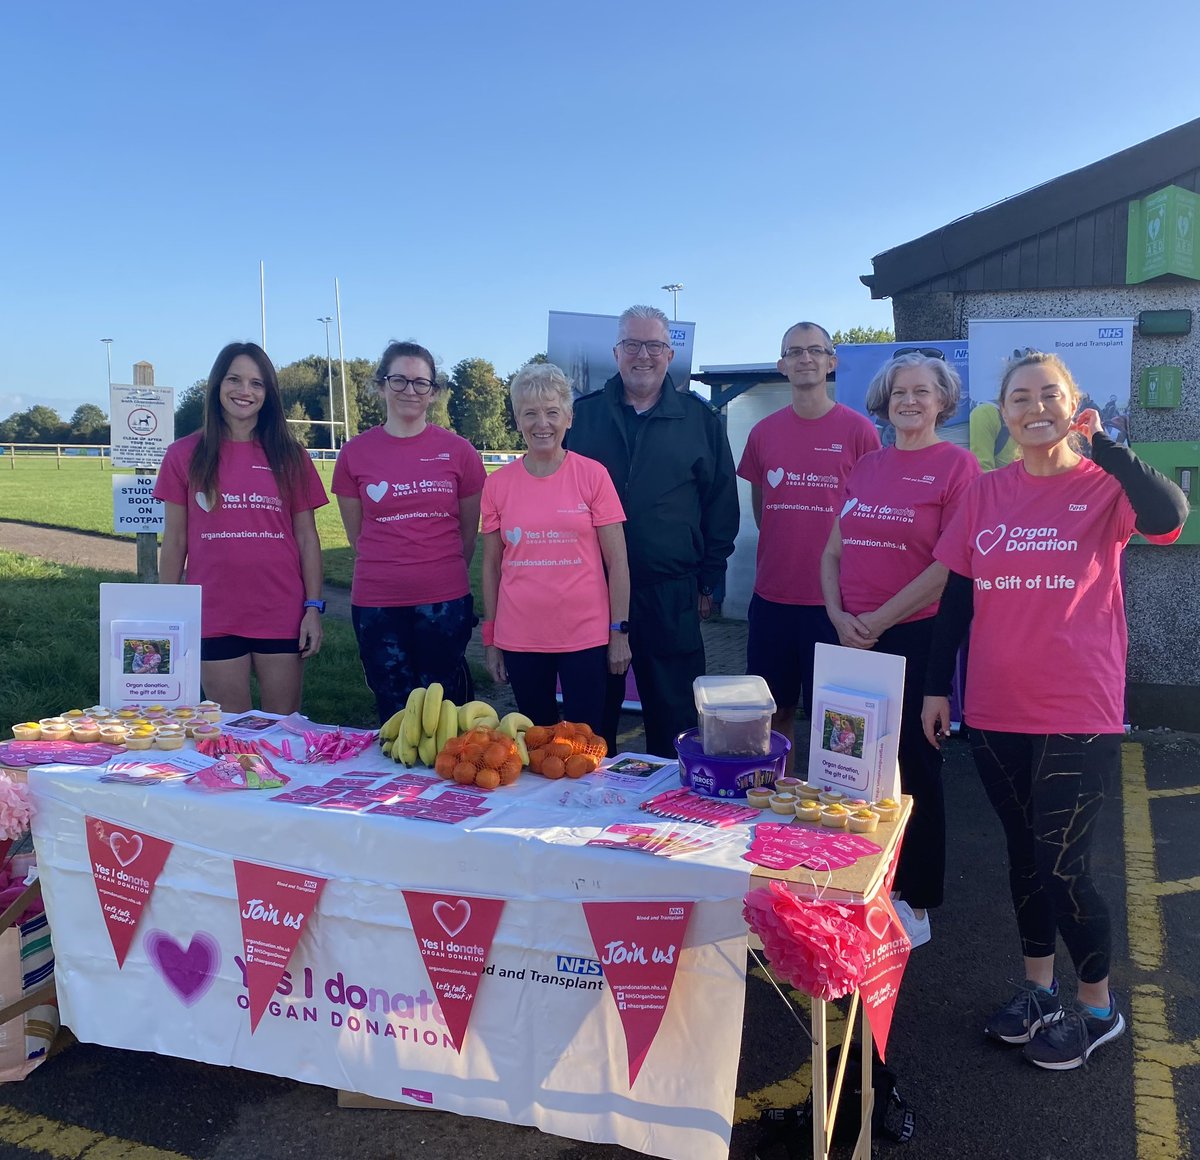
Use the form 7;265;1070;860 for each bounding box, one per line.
158;342;329;714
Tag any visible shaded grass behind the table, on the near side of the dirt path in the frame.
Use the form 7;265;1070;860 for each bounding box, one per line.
0;551;376;737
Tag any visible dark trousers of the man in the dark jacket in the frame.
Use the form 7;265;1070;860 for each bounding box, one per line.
600;576;704;757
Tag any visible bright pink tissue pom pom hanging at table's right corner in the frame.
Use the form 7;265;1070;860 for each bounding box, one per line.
742;882;866;1000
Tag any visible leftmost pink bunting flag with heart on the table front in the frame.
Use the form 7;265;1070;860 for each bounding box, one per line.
84;817;173;967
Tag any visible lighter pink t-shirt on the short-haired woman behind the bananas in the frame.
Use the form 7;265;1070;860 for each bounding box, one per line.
482;451;625;653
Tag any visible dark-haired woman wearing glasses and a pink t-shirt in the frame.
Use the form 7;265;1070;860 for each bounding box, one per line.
334;342;485;722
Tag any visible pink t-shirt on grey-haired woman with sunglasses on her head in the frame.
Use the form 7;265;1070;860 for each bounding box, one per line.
839;443;979;624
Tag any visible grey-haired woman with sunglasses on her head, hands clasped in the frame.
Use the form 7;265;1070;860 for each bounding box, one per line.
821;350;979;946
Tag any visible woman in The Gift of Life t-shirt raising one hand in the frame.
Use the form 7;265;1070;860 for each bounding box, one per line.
923;351;1188;1071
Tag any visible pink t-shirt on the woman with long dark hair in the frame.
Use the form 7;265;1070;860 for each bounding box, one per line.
154;432;329;639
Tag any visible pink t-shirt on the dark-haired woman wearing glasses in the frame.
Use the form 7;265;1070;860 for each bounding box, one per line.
332;423;485;608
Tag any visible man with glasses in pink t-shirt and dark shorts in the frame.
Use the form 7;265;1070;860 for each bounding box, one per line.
738;323;880;770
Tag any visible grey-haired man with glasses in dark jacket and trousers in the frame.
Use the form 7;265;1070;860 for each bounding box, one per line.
568;306;738;757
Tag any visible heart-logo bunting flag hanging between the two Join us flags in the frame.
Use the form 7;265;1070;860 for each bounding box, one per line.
404;890;504;1053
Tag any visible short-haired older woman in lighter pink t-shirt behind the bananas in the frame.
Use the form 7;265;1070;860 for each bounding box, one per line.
482;362;630;732
